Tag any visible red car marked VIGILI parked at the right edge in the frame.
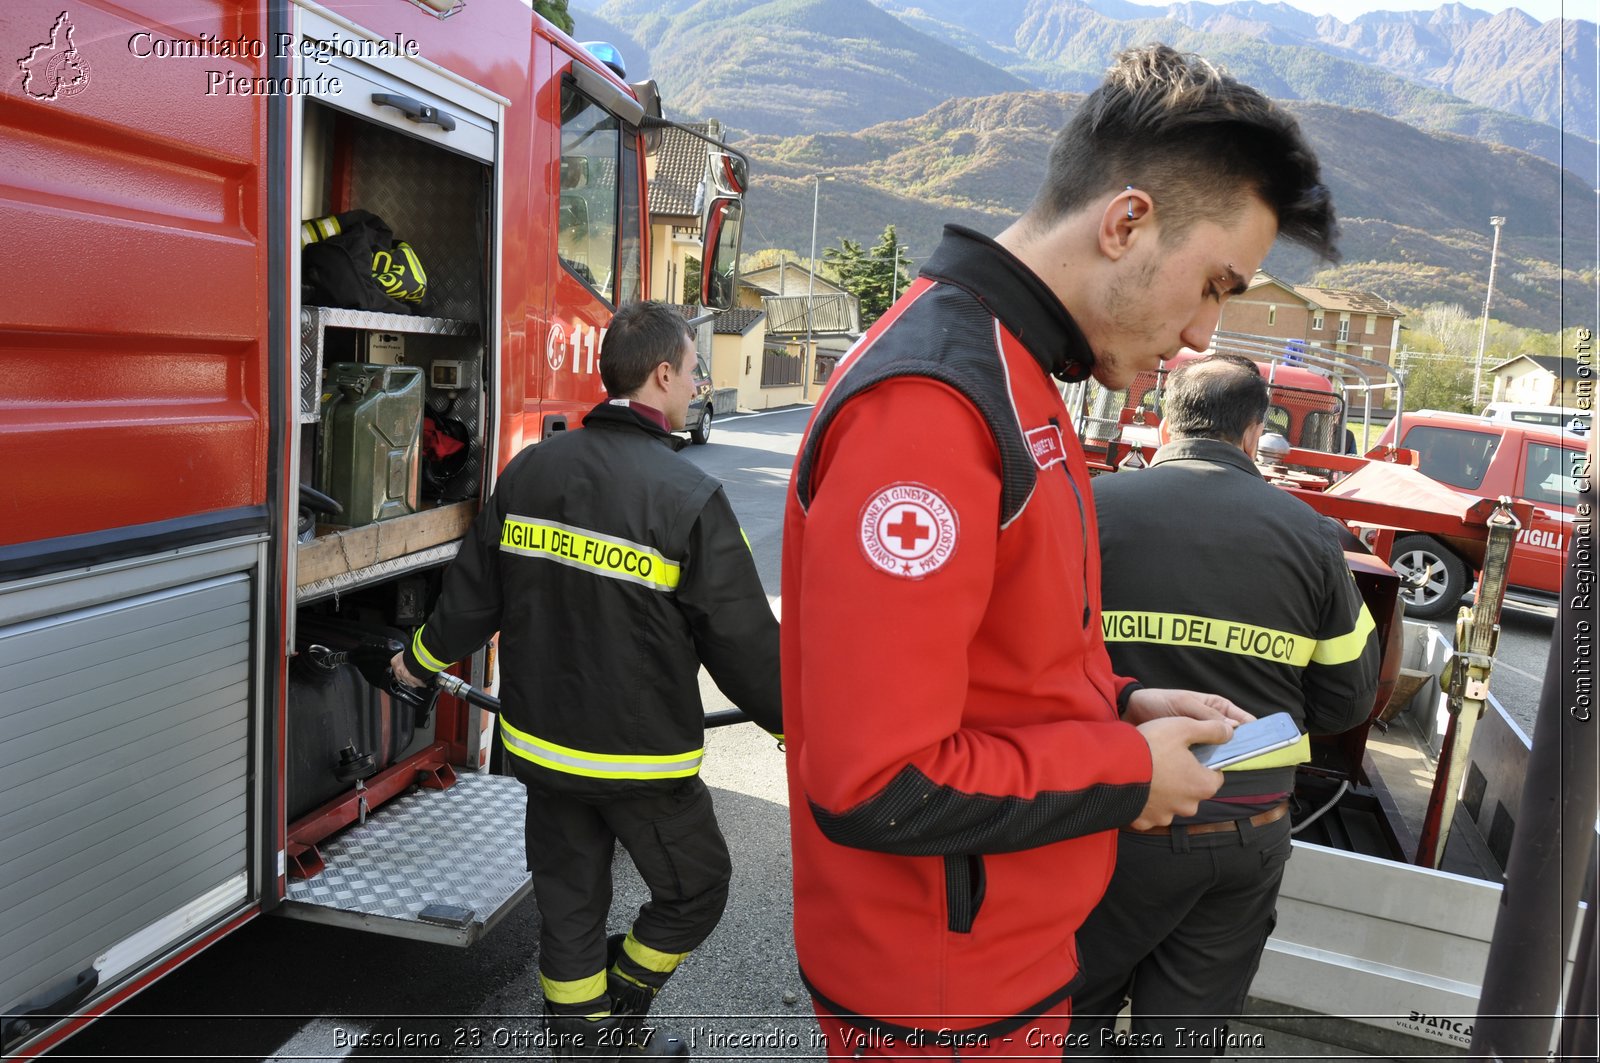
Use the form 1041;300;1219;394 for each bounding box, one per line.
1378;410;1587;620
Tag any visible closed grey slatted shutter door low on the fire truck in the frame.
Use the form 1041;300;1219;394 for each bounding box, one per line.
0;543;259;1050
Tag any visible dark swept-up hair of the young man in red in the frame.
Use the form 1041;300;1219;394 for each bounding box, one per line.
1029;45;1339;261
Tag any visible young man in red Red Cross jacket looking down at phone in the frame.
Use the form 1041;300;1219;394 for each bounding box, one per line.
782;39;1334;1058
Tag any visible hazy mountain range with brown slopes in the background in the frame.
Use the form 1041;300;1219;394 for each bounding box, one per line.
573;0;1600;330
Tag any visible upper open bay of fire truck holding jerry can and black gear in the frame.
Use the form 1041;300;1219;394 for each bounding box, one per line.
296;76;494;602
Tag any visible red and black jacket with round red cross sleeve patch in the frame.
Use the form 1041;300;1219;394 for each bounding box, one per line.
782;226;1150;1036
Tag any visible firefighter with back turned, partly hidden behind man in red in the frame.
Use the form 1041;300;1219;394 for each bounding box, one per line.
1072;354;1381;1057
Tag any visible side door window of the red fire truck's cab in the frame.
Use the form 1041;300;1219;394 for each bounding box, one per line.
555;85;617;301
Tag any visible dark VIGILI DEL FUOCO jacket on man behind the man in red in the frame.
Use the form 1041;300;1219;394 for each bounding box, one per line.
1094;439;1381;800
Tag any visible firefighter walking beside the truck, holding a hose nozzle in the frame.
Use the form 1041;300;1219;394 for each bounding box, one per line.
395;303;782;1057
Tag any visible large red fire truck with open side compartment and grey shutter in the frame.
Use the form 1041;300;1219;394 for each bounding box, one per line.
0;0;746;1057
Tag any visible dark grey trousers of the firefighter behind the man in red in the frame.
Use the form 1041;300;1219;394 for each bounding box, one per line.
1067;816;1290;1058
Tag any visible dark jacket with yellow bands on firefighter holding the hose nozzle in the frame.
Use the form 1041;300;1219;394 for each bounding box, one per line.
396;403;782;796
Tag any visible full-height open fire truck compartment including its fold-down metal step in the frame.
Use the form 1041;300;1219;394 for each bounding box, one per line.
278;8;528;945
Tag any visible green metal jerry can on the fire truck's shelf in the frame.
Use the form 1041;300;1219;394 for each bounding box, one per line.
322;362;422;527
